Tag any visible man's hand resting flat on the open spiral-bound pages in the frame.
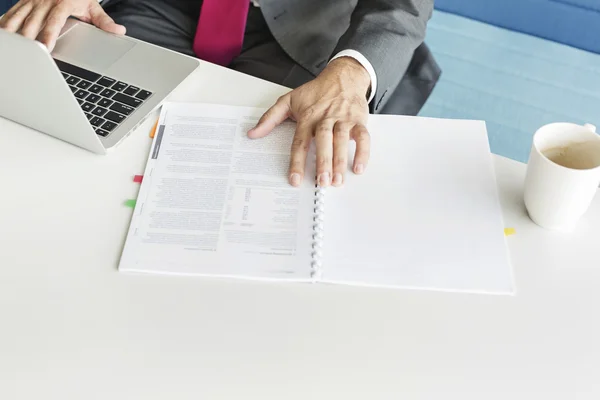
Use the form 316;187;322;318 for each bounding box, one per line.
248;57;371;187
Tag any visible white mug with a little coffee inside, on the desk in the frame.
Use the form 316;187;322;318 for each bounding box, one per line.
525;123;600;231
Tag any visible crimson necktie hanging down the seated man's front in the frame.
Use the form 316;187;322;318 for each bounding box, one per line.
194;0;250;66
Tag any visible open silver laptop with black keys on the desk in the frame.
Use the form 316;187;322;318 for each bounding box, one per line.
0;19;200;154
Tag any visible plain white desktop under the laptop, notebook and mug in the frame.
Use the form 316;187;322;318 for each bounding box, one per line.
0;64;600;400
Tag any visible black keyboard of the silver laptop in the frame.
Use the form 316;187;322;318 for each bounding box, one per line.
54;59;152;137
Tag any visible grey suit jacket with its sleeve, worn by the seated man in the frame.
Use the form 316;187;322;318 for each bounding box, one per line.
260;0;440;114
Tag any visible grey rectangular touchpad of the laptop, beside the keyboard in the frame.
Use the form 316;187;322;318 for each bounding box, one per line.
52;24;135;73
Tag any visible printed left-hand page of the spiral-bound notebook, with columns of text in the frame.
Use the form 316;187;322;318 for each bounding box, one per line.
119;103;315;281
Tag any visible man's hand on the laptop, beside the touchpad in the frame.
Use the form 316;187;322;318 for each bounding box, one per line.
0;0;125;51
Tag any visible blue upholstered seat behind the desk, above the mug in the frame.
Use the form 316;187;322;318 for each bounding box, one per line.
420;0;600;162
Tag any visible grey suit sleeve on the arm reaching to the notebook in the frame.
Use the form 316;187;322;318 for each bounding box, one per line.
333;0;433;112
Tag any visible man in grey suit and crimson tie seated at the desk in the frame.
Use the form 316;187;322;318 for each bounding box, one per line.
0;0;440;187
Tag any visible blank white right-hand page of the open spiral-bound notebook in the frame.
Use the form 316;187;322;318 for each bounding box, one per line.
322;115;513;293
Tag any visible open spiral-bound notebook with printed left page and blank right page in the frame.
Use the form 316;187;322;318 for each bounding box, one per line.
119;103;513;293
